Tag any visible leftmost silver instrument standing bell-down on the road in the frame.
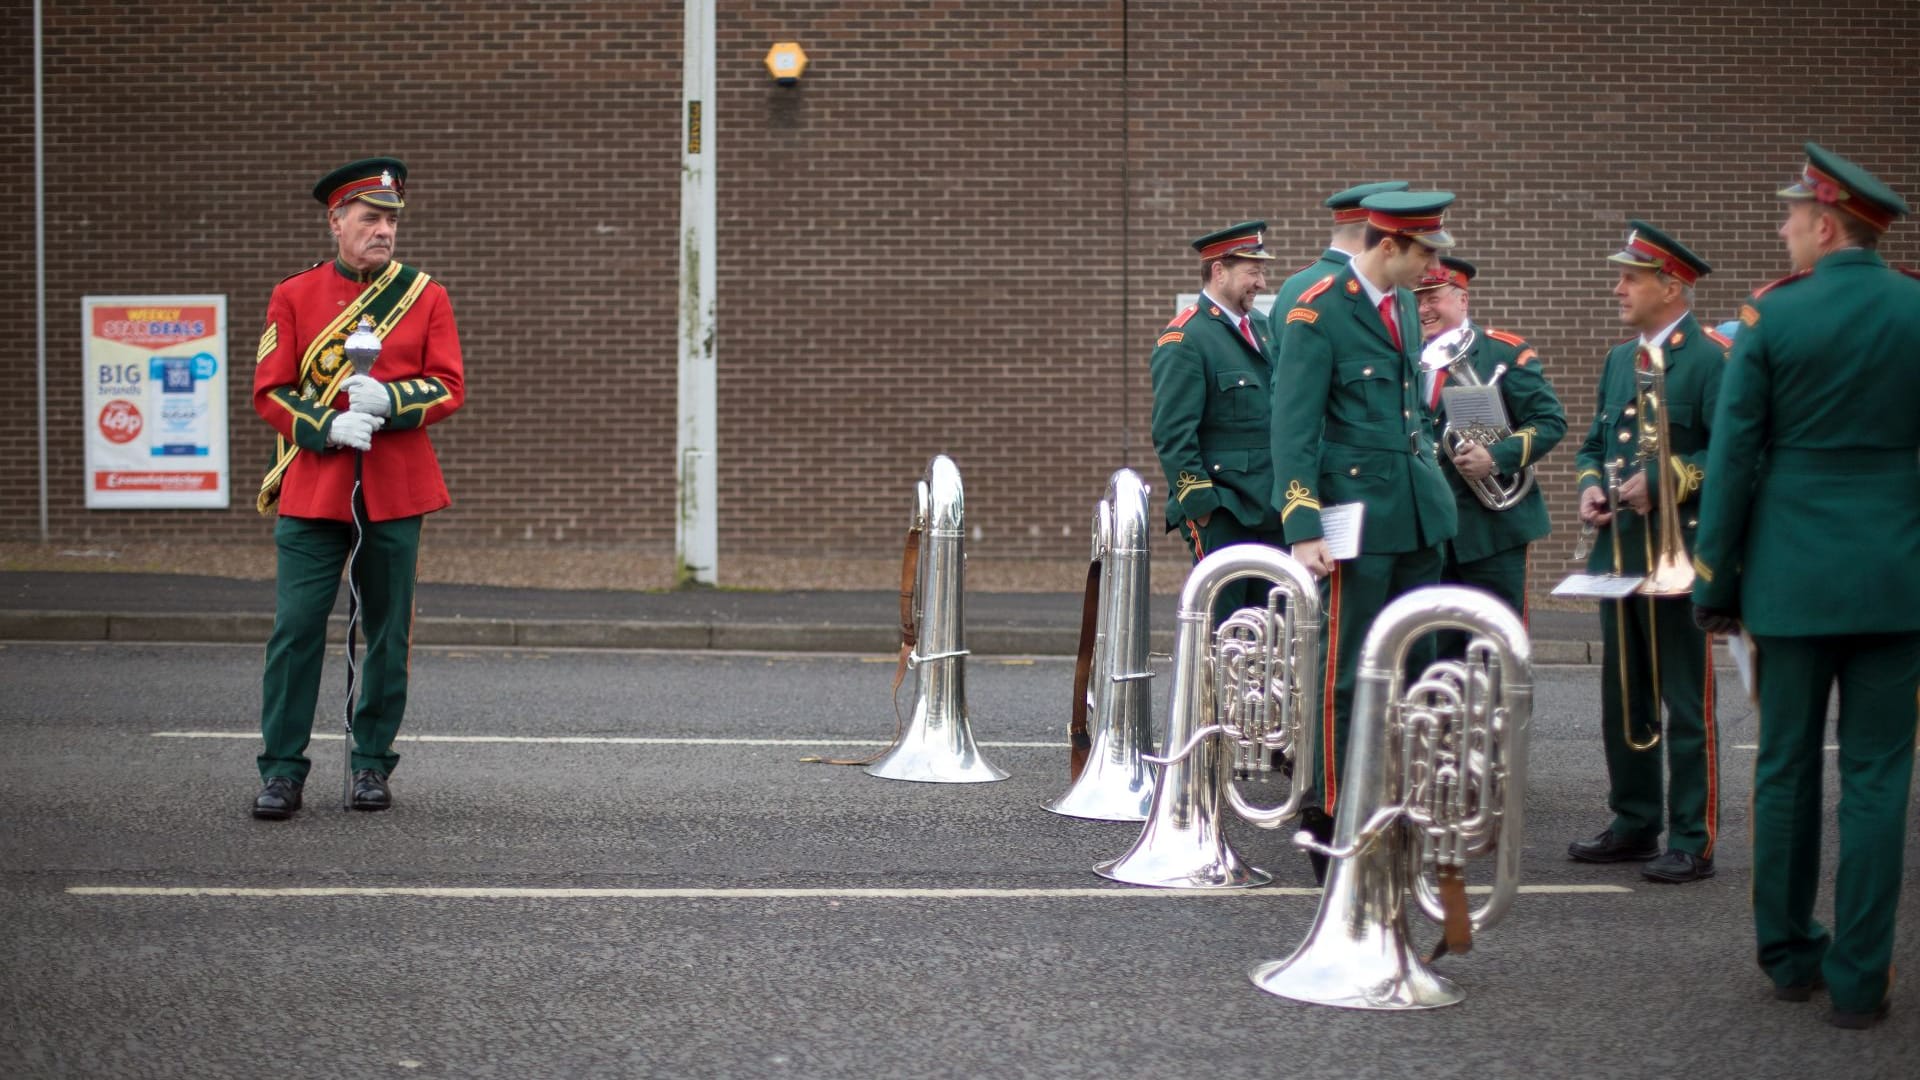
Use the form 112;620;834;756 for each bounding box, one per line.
866;454;1006;784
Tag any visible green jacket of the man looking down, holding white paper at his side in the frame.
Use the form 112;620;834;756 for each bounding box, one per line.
1273;265;1459;555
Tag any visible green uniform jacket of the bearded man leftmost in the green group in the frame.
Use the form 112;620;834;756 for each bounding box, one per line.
1152;292;1273;528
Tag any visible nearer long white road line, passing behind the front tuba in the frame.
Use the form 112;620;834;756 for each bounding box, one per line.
67;886;1634;899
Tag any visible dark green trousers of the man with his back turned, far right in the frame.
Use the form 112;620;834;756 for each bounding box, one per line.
1753;634;1920;1013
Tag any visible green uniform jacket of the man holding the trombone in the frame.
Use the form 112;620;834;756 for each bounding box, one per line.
1574;311;1728;575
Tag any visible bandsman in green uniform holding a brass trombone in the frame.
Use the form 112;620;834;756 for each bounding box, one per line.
1567;221;1728;882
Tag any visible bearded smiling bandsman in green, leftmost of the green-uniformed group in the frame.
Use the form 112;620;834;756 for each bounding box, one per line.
1152;221;1277;619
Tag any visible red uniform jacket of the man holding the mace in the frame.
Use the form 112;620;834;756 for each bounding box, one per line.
253;261;467;521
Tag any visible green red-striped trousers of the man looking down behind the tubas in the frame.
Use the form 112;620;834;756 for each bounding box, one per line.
1313;544;1444;813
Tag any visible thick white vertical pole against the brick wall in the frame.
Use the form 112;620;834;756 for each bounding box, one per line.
674;0;720;584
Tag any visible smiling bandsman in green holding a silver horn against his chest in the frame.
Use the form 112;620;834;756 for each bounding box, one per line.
1413;256;1567;655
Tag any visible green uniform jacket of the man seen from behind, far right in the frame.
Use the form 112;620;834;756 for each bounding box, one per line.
1693;248;1920;638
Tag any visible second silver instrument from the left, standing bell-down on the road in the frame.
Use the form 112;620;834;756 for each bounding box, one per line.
1046;469;1154;821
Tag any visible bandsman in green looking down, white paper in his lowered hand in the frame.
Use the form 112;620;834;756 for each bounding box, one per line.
1271;192;1457;876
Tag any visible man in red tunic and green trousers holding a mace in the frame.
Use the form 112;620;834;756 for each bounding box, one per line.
253;158;465;821
